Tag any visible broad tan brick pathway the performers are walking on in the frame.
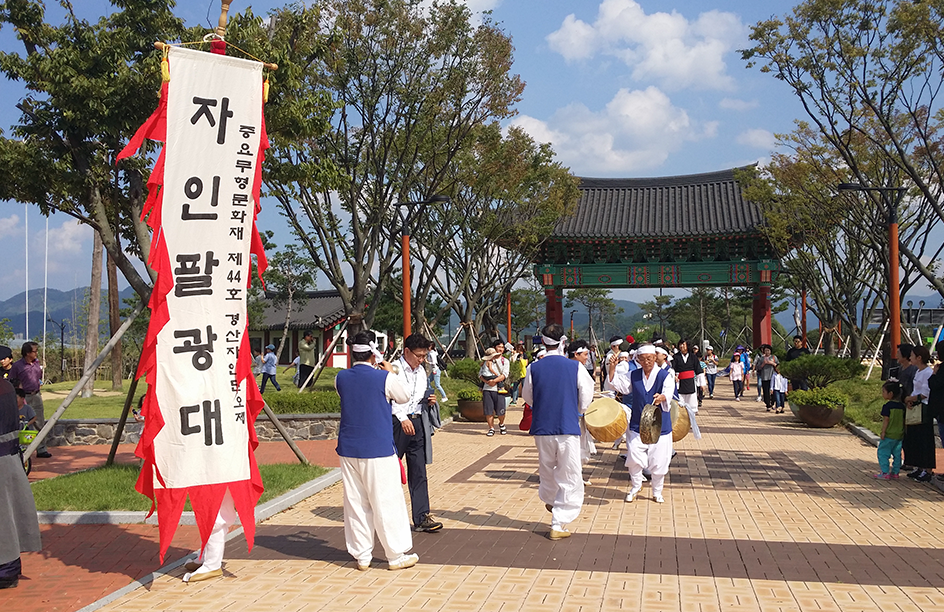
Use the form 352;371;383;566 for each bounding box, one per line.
77;390;944;612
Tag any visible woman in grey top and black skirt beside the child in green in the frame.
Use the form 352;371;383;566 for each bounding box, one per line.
904;346;936;482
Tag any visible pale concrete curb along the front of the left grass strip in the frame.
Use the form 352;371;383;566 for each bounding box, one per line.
36;468;341;525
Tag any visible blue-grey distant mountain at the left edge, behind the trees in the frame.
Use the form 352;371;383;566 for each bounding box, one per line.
0;287;134;341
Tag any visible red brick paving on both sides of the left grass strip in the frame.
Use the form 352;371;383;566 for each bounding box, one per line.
9;440;339;612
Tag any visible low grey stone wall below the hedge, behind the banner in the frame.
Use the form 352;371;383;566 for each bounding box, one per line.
46;413;341;446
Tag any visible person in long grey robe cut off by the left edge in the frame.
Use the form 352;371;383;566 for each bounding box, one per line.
0;358;42;588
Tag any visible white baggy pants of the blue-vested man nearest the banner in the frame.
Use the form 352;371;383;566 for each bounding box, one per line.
341;455;413;565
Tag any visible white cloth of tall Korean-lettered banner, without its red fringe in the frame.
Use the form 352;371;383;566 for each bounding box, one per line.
154;47;263;489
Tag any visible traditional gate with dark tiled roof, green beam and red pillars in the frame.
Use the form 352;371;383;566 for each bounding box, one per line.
534;169;779;345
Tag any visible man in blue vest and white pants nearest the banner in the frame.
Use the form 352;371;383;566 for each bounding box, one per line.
334;332;419;571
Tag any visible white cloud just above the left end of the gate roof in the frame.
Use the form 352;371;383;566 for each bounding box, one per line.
512;87;717;176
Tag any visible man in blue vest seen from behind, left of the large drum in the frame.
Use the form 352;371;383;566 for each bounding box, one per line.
521;324;594;540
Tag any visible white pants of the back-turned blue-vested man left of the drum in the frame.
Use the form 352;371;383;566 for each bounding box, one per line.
534;435;583;530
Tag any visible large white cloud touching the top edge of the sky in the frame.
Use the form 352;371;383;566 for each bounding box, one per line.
546;0;746;91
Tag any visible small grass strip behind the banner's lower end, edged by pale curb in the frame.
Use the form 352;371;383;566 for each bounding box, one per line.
31;463;328;512
